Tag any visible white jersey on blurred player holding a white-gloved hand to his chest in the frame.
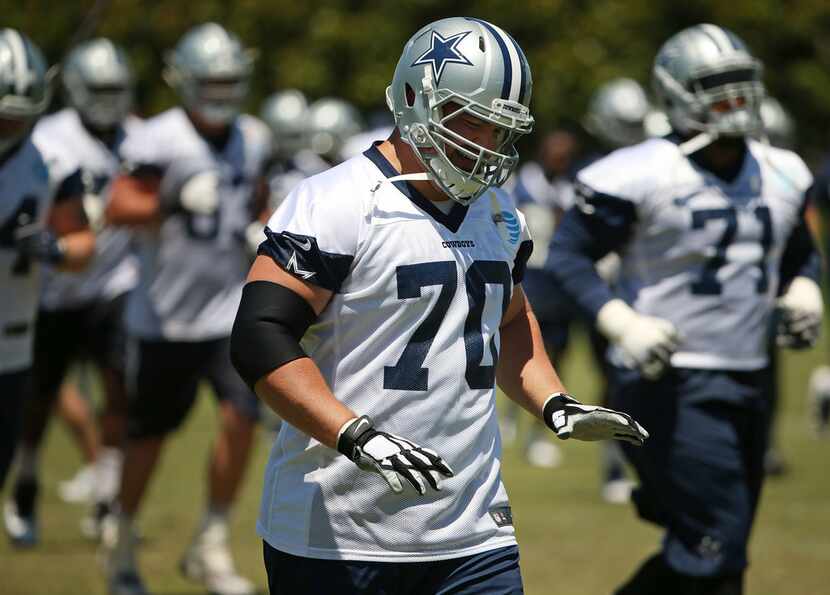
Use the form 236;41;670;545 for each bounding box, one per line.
121;108;271;341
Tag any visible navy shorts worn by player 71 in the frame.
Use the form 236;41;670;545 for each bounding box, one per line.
611;368;768;576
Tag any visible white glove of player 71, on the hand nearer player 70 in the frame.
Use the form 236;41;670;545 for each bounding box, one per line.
597;299;680;380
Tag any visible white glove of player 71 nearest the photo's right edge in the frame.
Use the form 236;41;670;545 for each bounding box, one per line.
776;277;824;349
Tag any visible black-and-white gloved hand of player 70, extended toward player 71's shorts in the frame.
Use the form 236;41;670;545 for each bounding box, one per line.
542;393;648;446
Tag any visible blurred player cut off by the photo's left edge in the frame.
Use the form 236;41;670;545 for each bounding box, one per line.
0;29;95;488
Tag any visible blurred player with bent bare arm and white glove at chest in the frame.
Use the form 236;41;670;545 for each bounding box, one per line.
100;23;270;595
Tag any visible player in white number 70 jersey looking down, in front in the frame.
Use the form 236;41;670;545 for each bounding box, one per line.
231;17;647;595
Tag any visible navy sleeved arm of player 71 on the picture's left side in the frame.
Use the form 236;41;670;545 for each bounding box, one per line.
545;185;637;319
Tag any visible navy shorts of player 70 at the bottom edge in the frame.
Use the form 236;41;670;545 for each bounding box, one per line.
262;541;524;595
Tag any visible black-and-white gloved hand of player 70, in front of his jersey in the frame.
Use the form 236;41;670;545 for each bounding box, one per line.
337;415;453;495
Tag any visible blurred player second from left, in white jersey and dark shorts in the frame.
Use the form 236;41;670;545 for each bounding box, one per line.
7;38;138;545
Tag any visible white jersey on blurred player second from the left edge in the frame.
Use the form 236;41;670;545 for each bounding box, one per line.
33;108;141;310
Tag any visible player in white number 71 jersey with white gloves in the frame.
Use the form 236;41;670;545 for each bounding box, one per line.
549;24;822;595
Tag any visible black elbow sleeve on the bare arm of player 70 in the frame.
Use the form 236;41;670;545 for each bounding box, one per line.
231;281;317;389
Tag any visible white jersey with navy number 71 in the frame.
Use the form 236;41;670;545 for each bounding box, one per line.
578;139;812;370
